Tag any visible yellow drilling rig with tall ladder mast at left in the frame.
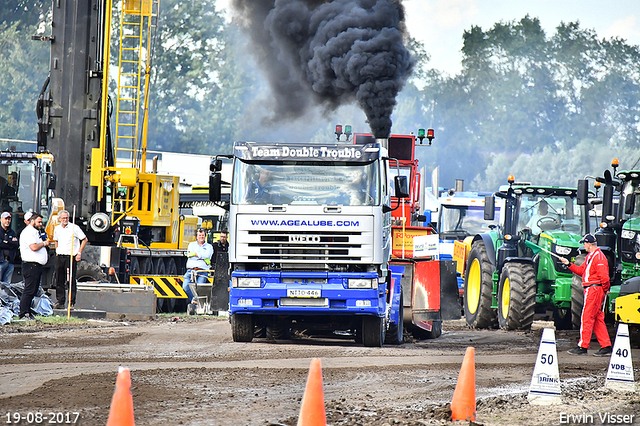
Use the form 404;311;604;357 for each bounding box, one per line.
38;0;197;309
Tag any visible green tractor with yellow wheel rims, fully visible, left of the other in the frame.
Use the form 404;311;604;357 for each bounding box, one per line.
464;176;589;330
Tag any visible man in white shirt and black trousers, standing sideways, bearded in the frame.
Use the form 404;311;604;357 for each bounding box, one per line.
19;213;49;318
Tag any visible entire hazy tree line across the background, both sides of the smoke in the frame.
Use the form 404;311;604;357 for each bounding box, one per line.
0;4;640;190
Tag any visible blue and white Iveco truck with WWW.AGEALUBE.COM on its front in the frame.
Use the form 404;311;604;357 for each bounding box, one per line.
209;139;458;346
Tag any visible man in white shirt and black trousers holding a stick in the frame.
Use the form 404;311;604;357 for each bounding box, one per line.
53;210;87;309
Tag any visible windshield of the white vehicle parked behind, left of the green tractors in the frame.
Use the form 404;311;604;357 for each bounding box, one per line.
438;205;500;240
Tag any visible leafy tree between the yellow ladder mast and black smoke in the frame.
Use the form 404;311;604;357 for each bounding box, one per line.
148;0;250;153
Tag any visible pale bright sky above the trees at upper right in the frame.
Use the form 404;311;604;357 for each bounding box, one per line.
217;0;640;74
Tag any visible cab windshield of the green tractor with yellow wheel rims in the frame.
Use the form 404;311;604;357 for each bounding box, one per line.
518;194;586;235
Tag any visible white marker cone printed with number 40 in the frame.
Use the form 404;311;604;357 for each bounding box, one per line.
604;322;636;392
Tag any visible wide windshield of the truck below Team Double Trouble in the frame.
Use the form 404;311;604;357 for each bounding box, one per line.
232;159;380;206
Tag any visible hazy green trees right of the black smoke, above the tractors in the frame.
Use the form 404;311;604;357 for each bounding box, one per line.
421;16;640;189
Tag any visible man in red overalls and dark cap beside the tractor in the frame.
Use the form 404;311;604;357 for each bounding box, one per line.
561;234;611;356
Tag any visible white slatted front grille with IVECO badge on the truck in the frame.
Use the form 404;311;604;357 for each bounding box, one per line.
236;231;373;263
